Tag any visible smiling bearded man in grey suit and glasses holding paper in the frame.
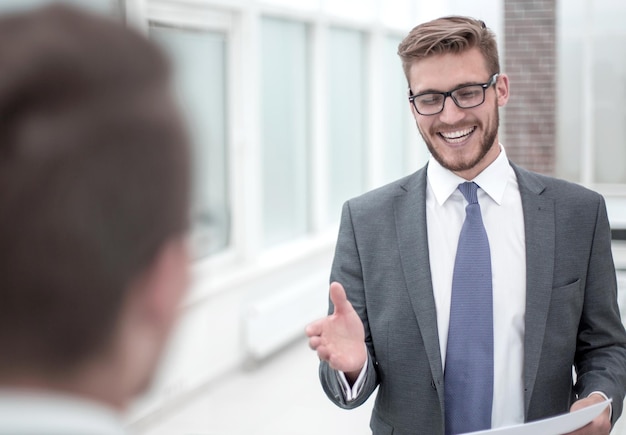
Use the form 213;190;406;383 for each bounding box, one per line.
306;17;626;435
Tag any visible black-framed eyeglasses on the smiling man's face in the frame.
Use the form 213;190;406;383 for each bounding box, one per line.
409;73;498;116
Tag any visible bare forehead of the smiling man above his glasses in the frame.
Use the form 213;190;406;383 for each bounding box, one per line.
409;48;490;94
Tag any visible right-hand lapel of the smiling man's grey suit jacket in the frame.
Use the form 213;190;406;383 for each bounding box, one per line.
513;165;555;415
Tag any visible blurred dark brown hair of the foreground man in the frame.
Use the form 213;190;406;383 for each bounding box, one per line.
0;5;190;371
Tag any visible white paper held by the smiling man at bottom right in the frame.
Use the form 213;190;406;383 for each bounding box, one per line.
458;399;611;435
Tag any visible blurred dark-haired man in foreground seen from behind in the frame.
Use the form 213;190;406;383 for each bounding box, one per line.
0;6;189;435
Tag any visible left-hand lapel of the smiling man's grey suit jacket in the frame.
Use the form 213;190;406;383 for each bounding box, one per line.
394;167;443;409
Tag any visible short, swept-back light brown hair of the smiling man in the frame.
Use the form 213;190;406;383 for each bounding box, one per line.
398;16;500;81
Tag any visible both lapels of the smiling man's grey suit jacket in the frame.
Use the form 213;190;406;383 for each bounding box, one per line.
394;164;555;413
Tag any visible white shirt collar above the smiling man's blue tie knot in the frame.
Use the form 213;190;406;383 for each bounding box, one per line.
426;144;513;205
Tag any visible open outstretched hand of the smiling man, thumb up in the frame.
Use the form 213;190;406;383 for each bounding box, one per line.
305;282;367;381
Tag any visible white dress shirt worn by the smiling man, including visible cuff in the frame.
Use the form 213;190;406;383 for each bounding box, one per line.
338;145;526;428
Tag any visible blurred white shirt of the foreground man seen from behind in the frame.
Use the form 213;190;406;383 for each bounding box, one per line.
0;389;126;435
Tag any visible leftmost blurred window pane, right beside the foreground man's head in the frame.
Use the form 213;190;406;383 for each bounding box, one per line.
150;26;230;257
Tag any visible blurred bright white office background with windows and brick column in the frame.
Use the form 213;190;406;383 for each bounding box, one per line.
0;0;626;435
